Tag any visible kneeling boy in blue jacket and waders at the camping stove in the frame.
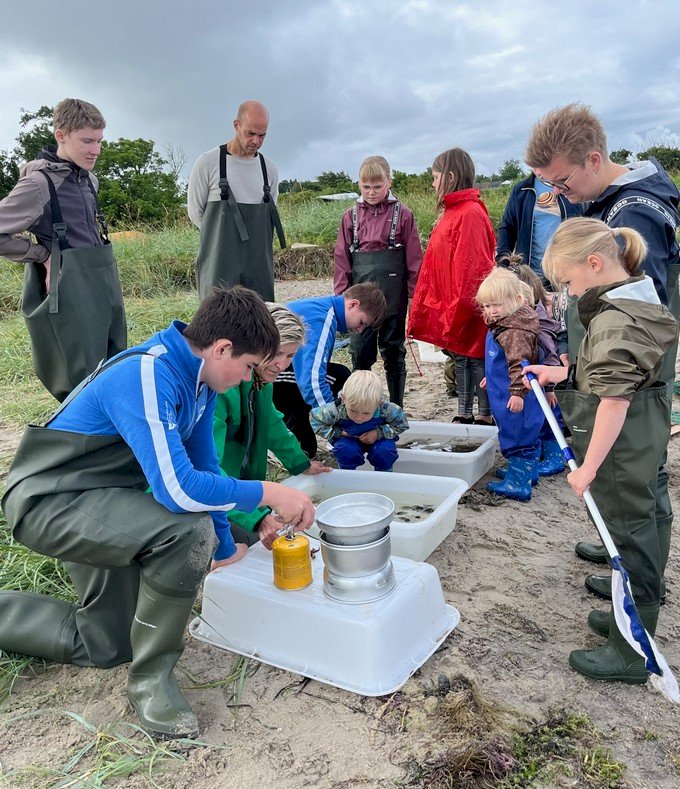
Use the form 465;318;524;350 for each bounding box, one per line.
0;287;314;738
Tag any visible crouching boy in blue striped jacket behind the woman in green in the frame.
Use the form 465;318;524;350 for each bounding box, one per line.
274;282;387;458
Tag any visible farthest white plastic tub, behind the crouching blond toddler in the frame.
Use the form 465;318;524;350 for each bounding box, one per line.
360;421;498;492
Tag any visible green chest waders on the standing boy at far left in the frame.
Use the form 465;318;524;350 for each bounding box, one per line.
22;171;127;402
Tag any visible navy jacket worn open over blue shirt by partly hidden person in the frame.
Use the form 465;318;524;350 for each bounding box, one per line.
496;174;581;266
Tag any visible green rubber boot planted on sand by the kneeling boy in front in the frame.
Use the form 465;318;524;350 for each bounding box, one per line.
127;581;198;739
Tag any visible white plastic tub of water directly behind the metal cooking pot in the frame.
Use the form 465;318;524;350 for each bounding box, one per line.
283;469;468;562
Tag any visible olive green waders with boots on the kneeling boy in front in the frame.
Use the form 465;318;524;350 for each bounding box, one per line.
0;360;215;737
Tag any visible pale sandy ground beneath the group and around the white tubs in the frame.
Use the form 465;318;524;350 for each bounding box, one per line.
0;281;680;789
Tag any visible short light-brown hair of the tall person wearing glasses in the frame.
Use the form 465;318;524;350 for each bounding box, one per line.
524;102;607;168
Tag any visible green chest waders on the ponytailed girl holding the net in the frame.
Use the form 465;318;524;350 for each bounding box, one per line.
555;382;669;605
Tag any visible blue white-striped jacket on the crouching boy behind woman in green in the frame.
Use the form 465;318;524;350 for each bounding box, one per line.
286;296;347;408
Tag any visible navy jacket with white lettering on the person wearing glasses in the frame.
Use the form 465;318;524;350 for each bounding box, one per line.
584;158;680;305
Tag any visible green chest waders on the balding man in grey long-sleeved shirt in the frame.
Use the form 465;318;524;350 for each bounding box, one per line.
196;145;286;301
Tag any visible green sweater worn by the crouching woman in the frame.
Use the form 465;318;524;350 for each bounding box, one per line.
213;381;311;531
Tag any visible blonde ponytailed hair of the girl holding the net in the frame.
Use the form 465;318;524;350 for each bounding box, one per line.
543;217;647;285
